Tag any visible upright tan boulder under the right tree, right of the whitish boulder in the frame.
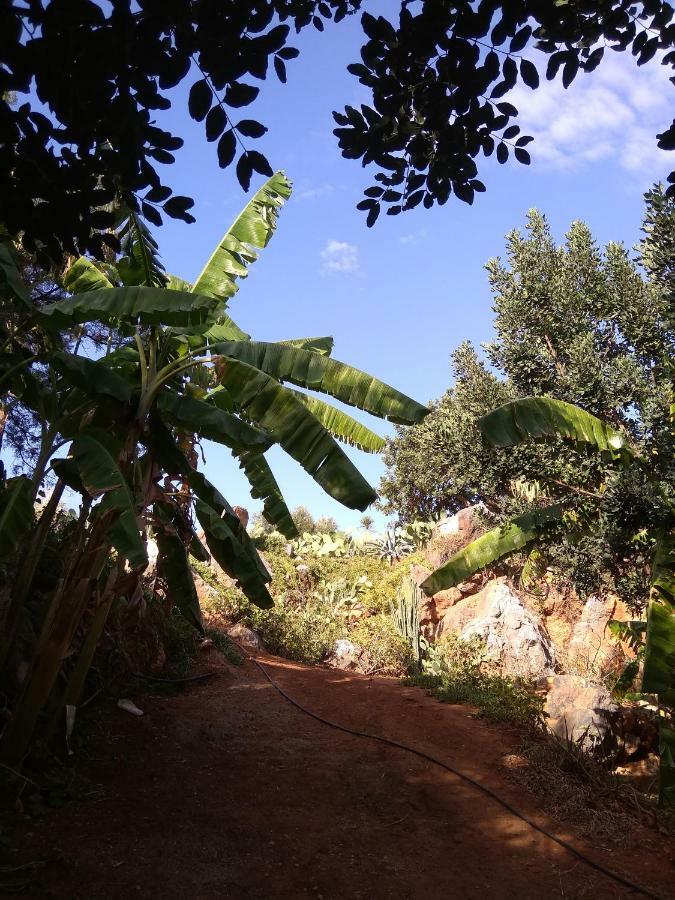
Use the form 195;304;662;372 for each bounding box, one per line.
567;597;633;677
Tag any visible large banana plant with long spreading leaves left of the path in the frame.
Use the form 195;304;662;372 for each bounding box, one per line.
0;173;426;765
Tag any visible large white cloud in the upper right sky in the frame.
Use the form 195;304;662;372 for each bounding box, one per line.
505;51;673;179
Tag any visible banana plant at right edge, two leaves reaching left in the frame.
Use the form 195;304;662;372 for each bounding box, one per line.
422;397;675;806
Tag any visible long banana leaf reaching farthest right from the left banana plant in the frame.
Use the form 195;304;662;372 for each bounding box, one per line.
212;341;429;425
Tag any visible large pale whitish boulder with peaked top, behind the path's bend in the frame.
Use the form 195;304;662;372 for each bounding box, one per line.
439;578;555;678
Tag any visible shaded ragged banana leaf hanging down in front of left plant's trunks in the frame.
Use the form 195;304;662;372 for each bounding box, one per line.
70;434;148;569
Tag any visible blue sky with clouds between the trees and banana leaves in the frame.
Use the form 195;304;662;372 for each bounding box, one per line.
141;2;672;527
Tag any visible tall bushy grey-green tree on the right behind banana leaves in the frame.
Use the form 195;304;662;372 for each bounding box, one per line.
381;188;675;598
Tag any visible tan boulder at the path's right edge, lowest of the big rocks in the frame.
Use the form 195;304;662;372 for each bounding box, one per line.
541;675;617;750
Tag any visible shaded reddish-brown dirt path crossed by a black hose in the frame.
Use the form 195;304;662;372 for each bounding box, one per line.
5;656;675;900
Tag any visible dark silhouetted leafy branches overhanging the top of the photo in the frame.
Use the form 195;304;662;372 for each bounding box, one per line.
0;0;675;258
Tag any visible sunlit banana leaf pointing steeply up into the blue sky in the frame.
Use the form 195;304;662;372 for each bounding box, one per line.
193;172;291;300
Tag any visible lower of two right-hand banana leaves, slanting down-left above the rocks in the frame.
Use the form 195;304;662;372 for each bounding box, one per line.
421;503;564;596
